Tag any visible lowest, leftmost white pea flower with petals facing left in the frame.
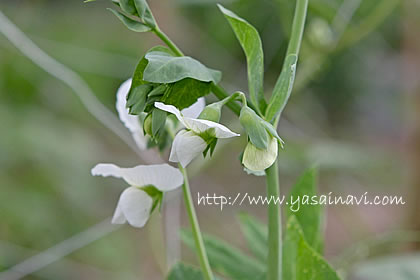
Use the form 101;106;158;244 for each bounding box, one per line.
91;163;184;228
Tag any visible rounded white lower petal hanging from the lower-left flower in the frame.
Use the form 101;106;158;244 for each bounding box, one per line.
112;187;153;227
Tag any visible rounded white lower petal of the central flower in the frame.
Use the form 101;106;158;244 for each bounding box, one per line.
169;129;207;167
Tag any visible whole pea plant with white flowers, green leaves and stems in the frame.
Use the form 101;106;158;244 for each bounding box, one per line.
92;0;339;280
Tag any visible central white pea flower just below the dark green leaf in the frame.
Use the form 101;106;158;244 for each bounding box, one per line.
155;102;239;167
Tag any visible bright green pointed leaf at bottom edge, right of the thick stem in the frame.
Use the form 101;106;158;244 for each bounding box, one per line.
283;216;340;280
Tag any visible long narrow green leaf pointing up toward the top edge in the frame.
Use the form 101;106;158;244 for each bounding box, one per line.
218;5;266;112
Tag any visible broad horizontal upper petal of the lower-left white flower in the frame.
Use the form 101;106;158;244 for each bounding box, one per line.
92;163;184;192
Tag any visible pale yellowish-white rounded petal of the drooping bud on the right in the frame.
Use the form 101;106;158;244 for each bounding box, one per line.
242;137;278;171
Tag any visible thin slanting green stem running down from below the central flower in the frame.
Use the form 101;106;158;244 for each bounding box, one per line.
178;164;213;280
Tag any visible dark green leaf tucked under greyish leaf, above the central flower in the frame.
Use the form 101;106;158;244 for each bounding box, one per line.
161;78;210;110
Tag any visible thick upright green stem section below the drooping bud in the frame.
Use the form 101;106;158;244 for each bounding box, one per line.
266;160;282;280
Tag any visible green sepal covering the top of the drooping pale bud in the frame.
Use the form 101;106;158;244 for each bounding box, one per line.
239;106;269;150
